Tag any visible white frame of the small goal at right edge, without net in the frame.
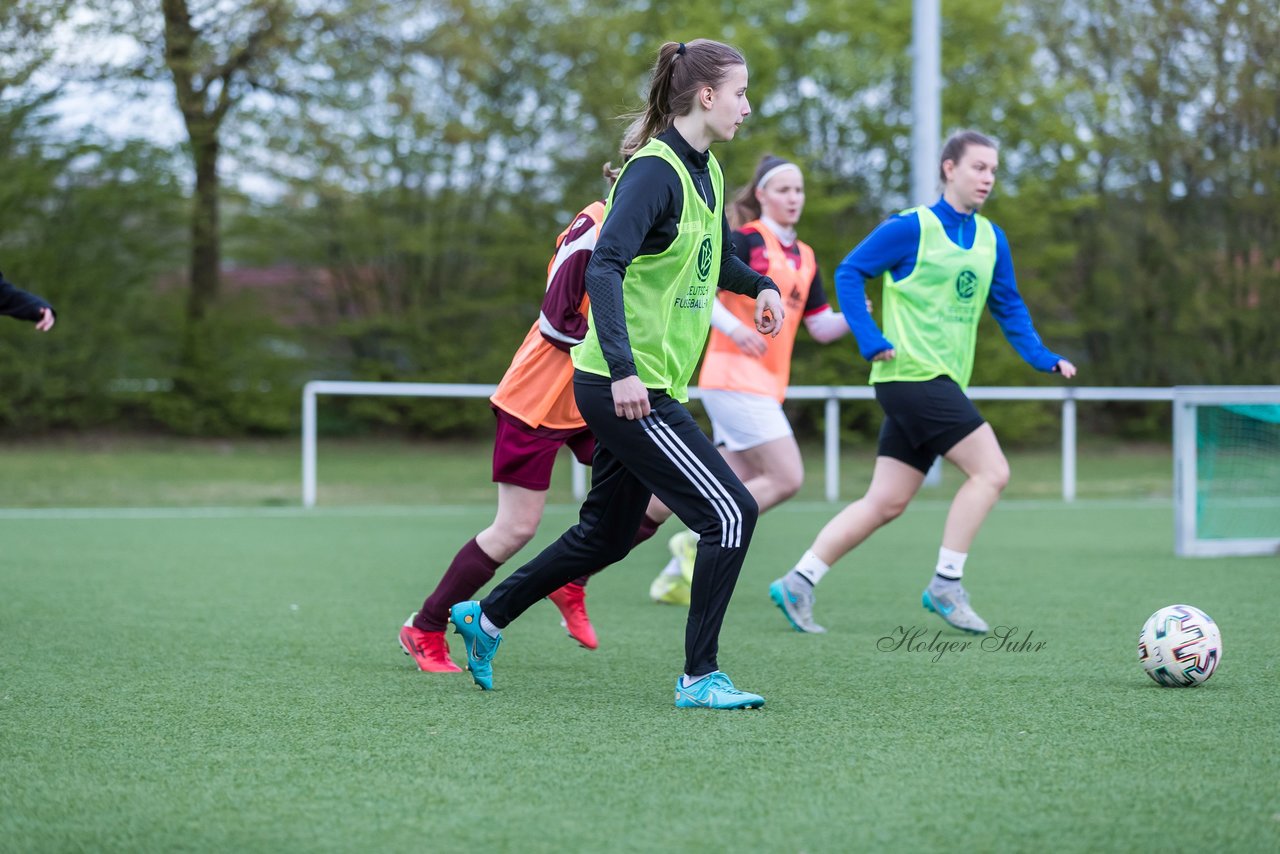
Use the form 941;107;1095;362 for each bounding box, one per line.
1174;385;1280;557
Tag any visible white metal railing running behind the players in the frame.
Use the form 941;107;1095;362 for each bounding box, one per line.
302;380;1174;507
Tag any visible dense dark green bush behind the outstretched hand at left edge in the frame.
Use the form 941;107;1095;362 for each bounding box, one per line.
0;95;182;433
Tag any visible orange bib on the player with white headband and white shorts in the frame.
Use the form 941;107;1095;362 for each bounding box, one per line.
698;220;818;403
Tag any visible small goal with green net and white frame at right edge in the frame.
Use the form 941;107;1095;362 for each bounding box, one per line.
1174;385;1280;557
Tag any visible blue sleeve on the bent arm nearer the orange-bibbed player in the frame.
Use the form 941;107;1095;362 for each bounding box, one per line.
835;214;920;360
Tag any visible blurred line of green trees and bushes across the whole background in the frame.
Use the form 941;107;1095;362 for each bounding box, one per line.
0;0;1280;440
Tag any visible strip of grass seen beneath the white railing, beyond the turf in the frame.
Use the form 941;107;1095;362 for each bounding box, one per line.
0;437;1172;507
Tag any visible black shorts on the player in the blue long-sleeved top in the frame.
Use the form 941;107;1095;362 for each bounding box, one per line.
876;376;986;472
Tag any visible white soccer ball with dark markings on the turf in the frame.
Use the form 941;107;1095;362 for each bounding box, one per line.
1138;604;1222;688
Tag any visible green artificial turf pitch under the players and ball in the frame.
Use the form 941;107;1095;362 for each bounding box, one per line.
0;498;1280;851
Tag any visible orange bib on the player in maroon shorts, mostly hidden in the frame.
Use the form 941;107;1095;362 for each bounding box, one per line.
489;201;604;430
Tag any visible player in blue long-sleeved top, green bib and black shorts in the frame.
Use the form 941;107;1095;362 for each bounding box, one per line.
769;131;1075;634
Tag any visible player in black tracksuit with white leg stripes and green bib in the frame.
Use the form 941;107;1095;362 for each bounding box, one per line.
451;38;783;709
